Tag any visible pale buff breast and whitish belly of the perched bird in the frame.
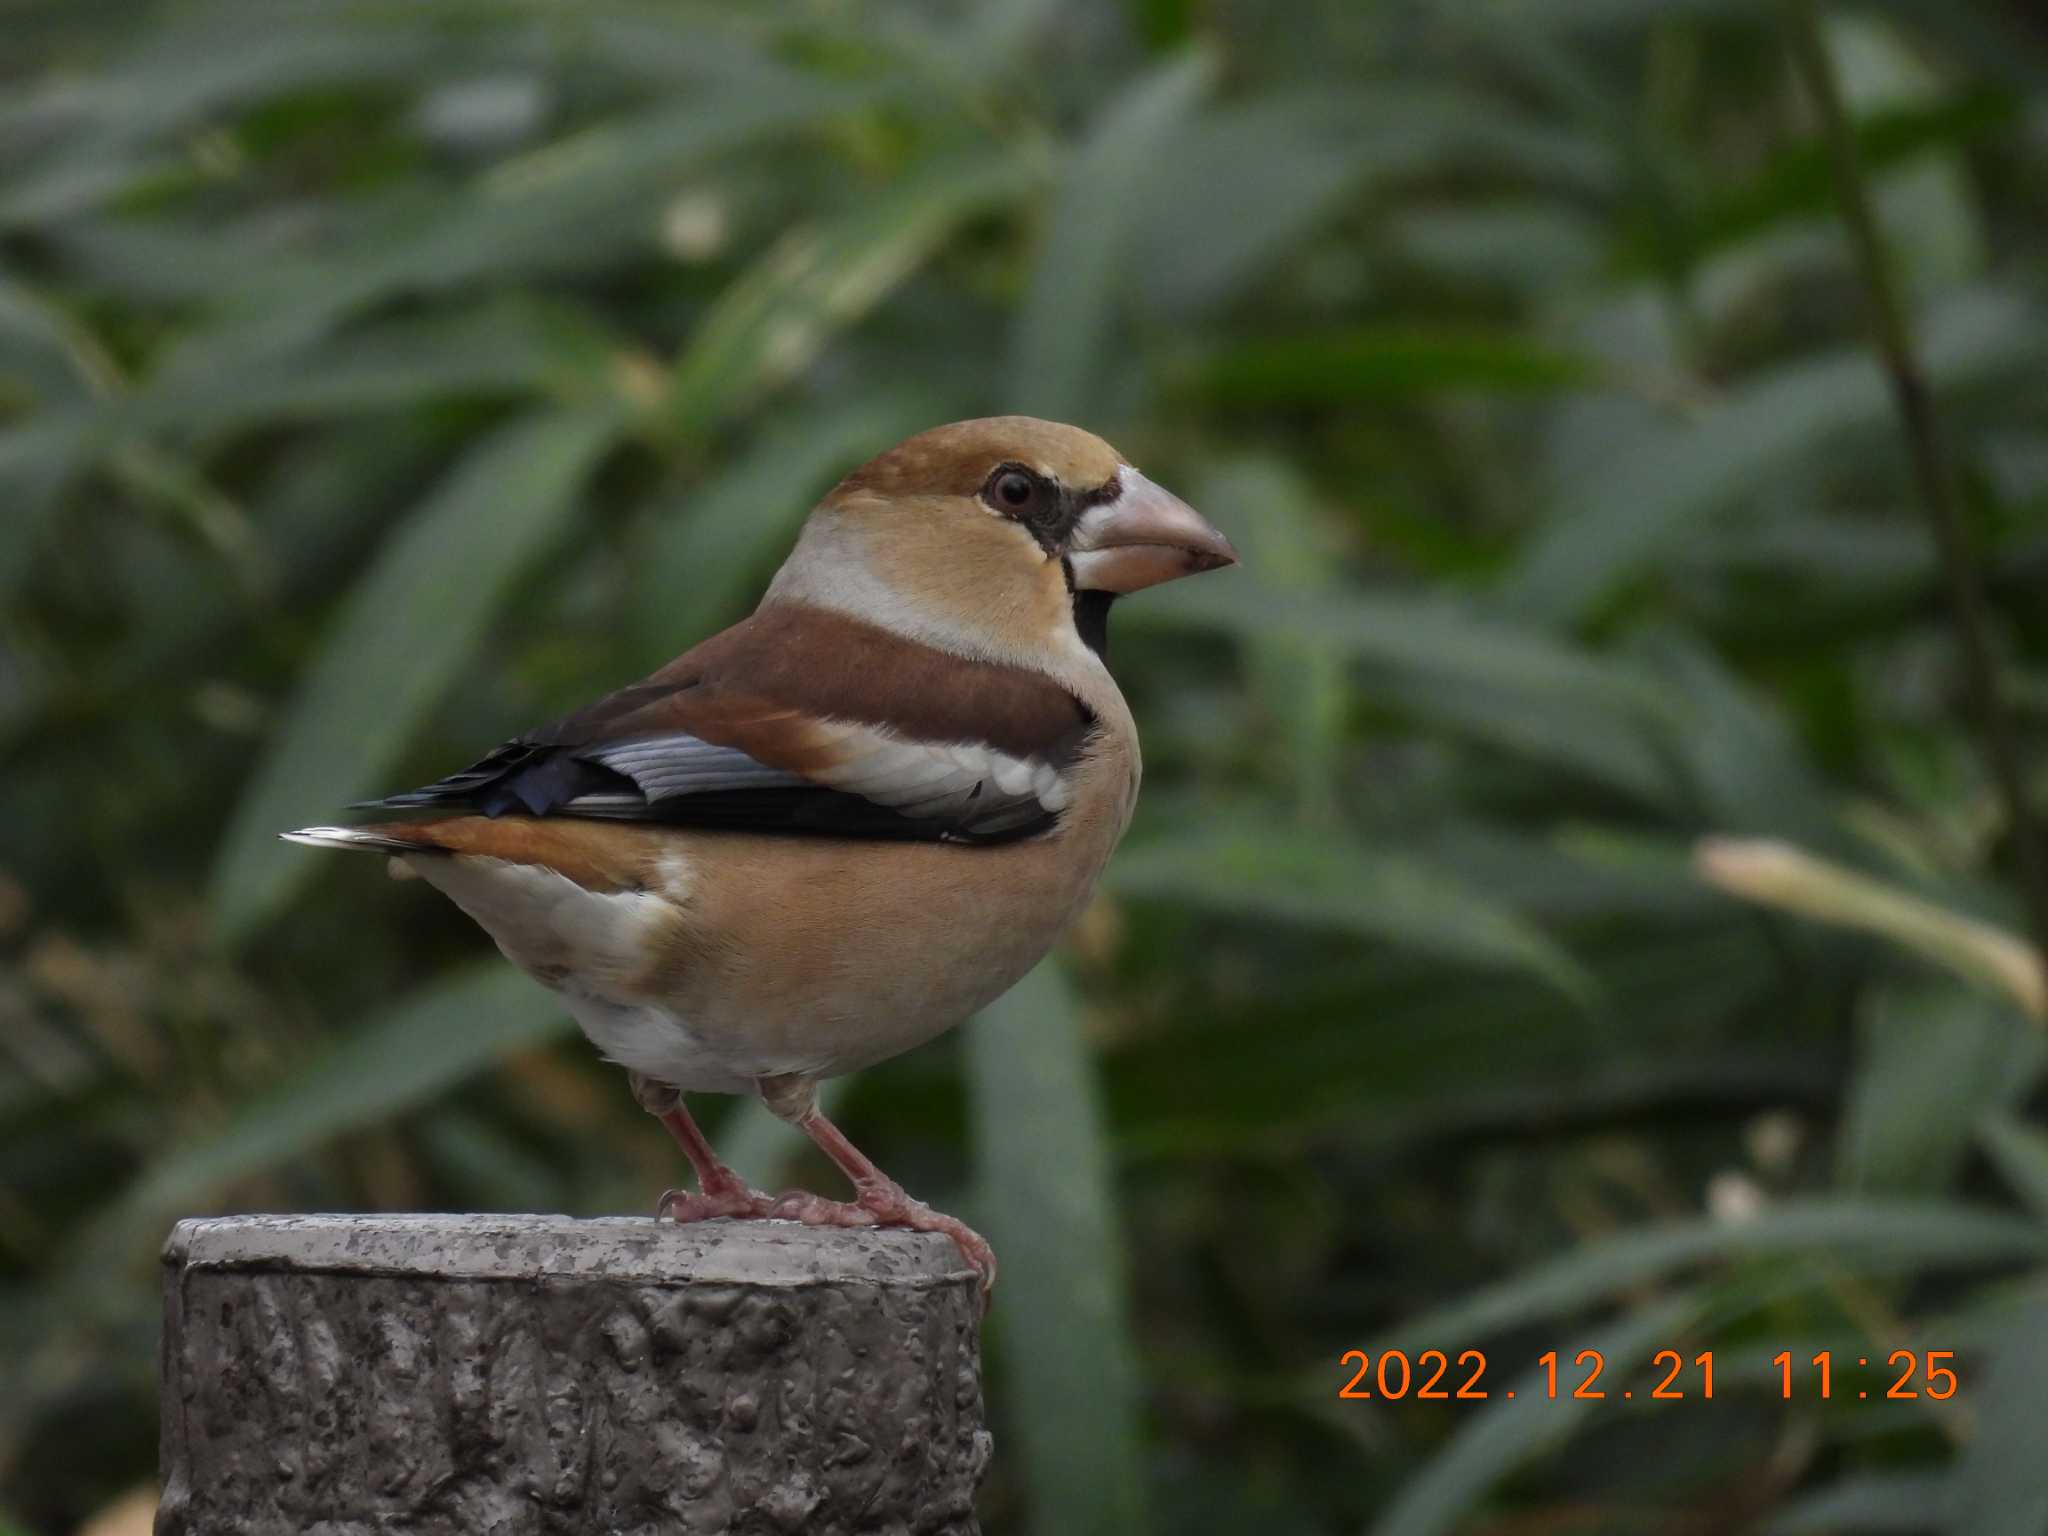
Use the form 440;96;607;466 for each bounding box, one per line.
408;720;1139;1092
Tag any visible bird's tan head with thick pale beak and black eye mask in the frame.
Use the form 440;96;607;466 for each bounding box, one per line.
770;416;1237;659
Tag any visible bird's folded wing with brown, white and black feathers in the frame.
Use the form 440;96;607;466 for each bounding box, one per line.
360;604;1094;842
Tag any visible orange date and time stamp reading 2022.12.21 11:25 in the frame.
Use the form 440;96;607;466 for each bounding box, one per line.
1337;1350;1962;1403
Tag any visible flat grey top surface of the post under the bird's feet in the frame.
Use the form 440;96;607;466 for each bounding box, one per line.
164;1212;973;1286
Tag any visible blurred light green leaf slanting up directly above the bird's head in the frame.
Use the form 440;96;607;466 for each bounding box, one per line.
668;145;1044;434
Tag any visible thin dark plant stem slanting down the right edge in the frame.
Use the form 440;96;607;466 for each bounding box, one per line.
1780;0;2048;965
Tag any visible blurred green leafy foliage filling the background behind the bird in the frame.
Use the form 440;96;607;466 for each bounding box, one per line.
0;0;2048;1536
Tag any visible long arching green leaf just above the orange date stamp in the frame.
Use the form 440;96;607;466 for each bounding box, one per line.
1386;1198;2048;1350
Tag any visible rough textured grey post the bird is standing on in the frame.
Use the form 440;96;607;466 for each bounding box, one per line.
156;1217;989;1536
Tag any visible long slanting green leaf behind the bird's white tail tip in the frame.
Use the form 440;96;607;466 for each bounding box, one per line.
209;410;623;942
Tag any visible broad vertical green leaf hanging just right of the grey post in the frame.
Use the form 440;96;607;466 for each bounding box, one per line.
965;961;1145;1536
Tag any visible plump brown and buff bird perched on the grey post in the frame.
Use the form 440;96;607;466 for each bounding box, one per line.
281;416;1237;1300
